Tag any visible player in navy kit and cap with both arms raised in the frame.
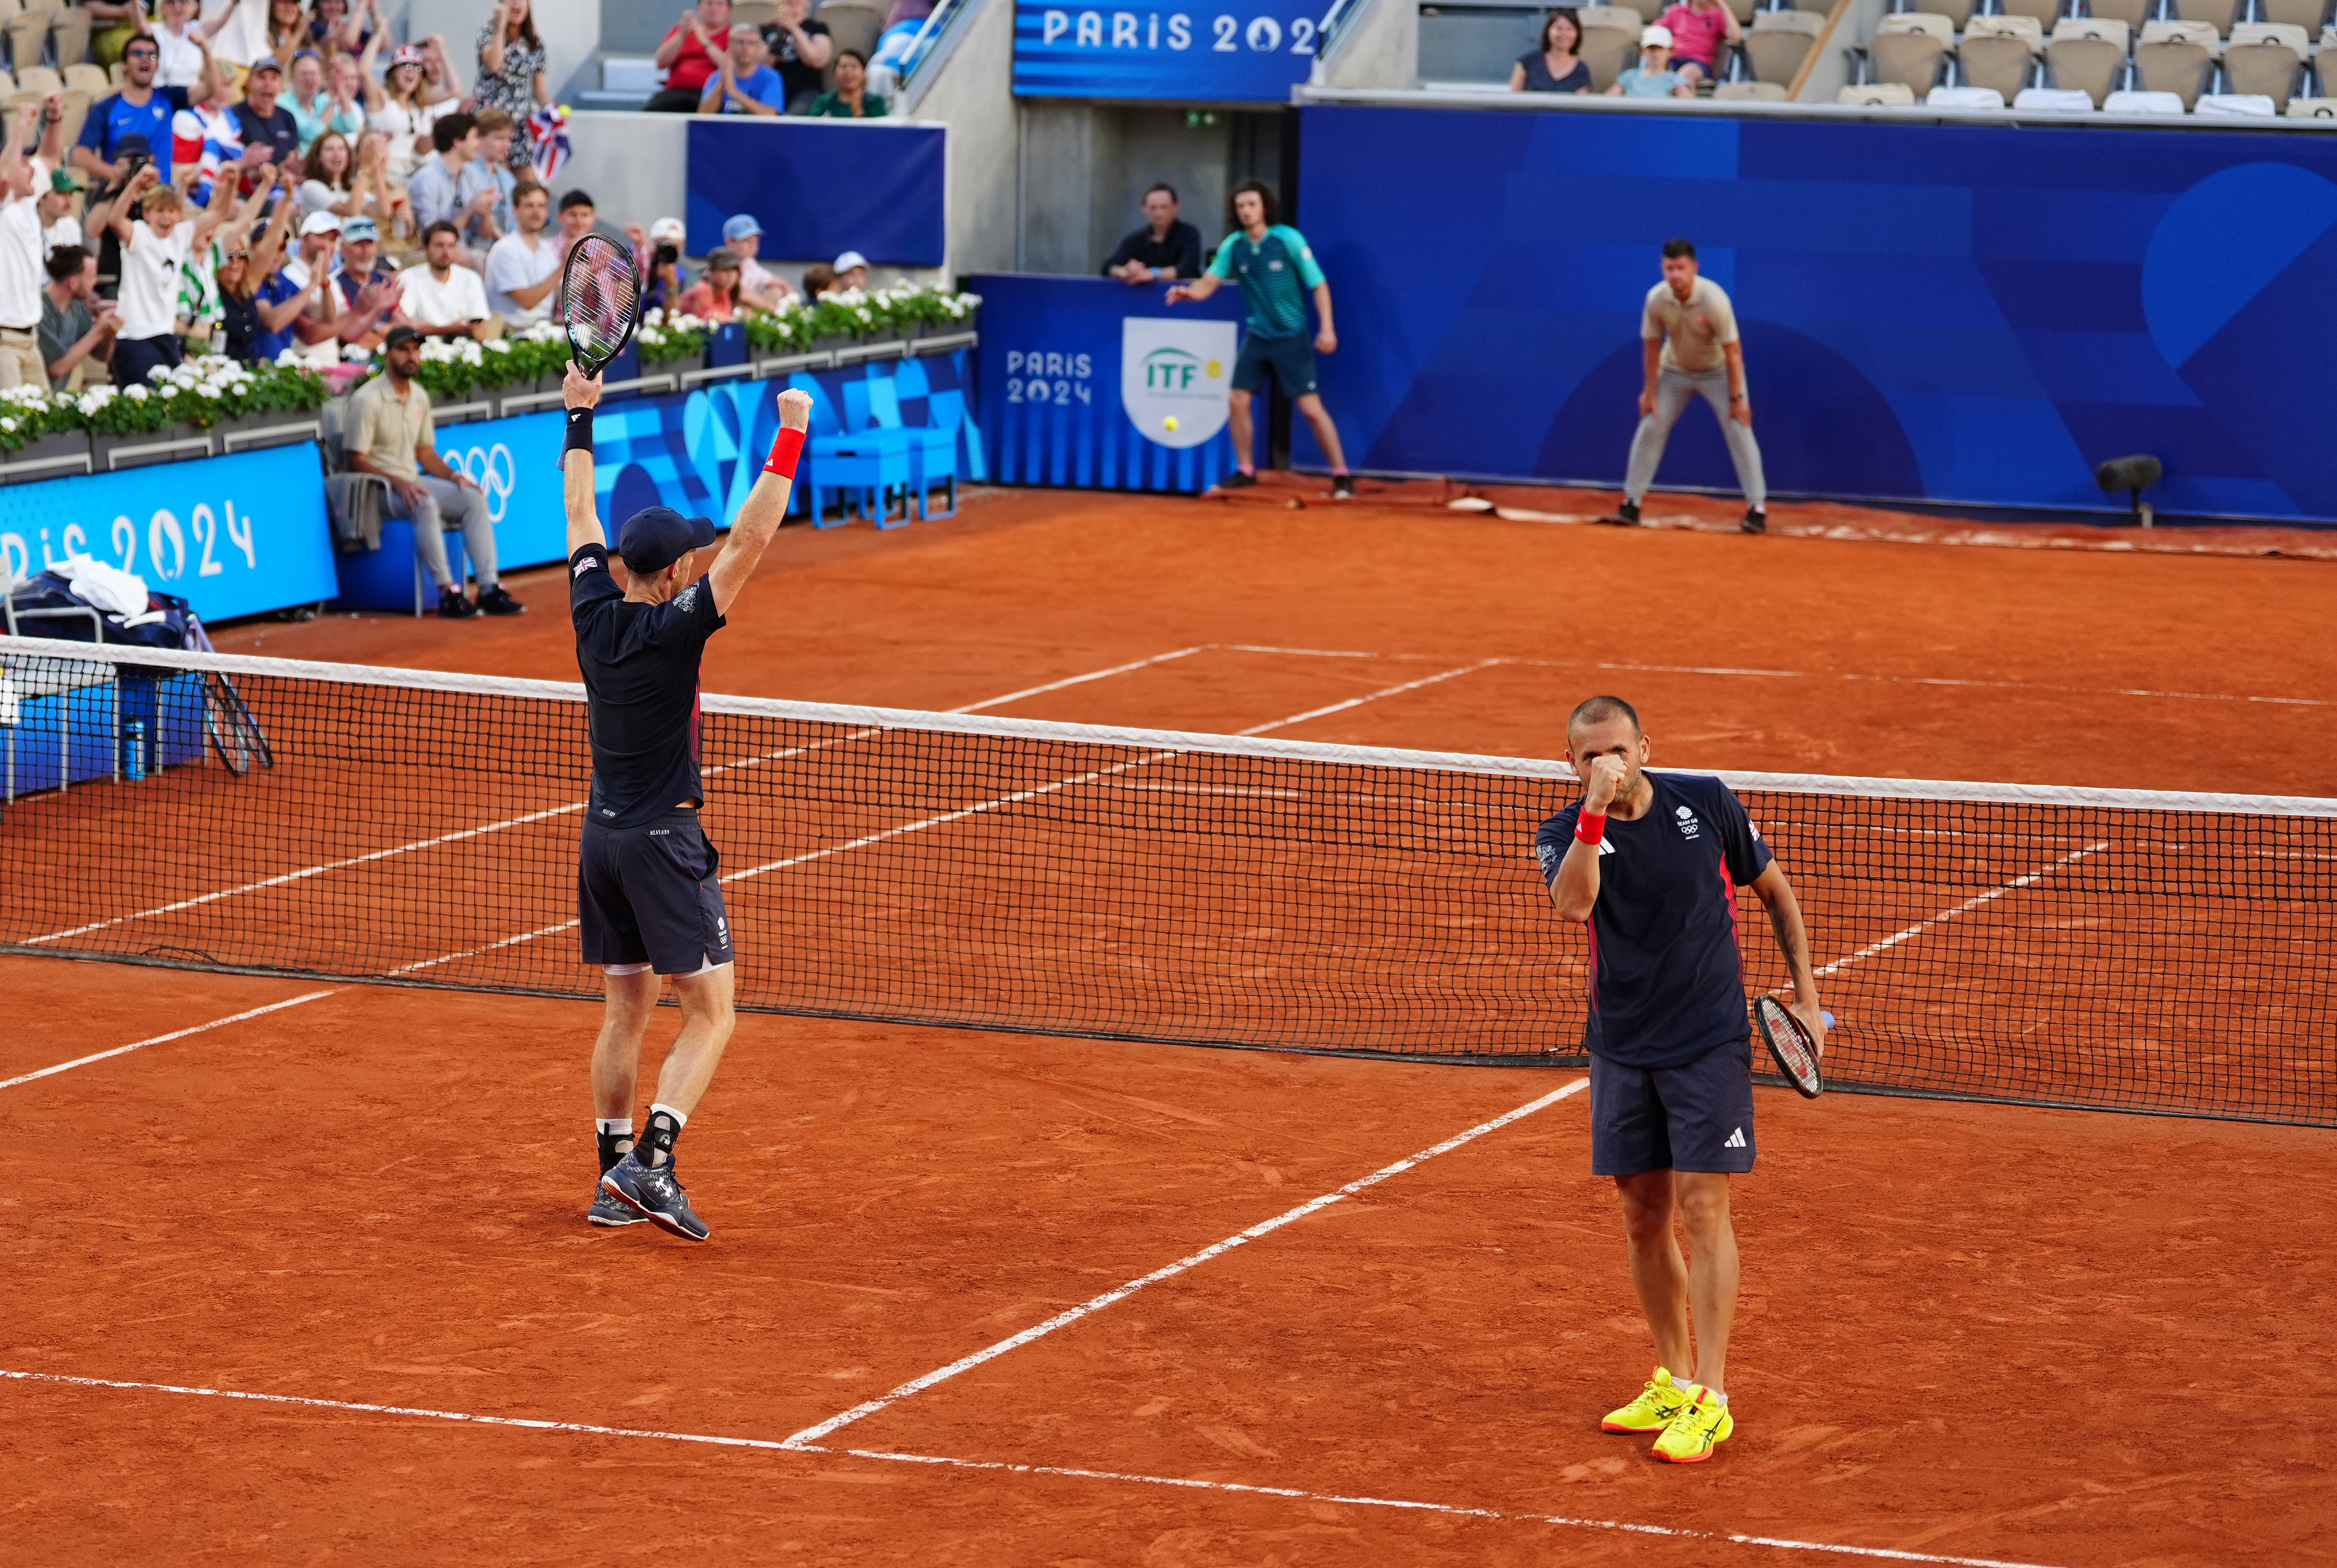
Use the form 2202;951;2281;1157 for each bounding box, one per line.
561;367;811;1241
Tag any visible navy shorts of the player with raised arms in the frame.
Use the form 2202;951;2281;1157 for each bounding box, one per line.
577;811;736;974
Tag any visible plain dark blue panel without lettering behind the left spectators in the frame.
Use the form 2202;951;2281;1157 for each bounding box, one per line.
687;114;949;266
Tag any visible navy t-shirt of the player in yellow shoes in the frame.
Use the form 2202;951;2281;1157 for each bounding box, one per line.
1533;774;1772;1068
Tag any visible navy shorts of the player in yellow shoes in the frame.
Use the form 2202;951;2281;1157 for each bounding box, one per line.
1592;1035;1753;1176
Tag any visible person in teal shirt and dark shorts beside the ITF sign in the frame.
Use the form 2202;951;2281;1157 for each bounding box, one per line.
1169;180;1355;495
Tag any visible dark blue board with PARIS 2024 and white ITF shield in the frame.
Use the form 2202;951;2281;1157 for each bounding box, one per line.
972;273;1264;493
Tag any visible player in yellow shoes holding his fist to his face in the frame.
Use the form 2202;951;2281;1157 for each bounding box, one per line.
1533;696;1825;1465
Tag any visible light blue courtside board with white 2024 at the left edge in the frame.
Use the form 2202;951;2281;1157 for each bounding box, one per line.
0;437;336;622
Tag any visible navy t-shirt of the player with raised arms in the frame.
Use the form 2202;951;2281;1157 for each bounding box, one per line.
568;545;722;827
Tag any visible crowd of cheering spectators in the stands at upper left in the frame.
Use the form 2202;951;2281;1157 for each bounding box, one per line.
0;0;883;390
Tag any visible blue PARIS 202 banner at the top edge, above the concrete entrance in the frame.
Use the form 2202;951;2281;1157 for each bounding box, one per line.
1014;0;1335;103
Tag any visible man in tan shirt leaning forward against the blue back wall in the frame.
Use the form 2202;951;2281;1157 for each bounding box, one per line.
1601;241;1769;533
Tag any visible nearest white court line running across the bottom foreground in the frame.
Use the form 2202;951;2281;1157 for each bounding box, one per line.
0;1367;2047;1568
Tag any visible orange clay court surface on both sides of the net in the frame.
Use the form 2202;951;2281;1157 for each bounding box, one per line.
18;484;2337;1568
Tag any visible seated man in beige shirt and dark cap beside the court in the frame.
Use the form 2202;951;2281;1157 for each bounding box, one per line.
348;327;526;622
